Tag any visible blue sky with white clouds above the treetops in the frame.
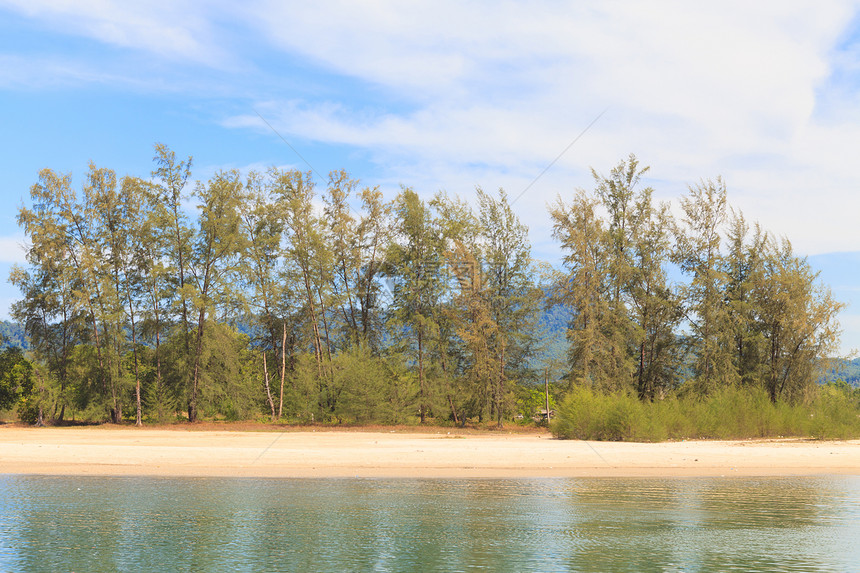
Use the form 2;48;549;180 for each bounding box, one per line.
0;0;860;354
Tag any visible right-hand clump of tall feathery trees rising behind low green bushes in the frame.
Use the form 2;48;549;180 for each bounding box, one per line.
550;155;844;402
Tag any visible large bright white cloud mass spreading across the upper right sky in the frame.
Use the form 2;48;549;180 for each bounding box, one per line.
226;2;860;252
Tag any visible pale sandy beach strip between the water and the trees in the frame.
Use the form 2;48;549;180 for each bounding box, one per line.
0;426;860;478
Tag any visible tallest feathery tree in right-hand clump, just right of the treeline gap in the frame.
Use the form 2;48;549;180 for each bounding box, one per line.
550;155;679;400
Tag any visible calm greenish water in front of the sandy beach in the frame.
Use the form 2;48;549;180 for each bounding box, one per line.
0;476;860;572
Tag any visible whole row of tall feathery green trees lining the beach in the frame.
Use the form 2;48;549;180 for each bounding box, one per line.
0;144;842;434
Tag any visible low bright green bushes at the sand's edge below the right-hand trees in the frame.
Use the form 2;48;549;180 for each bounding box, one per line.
552;384;860;442
